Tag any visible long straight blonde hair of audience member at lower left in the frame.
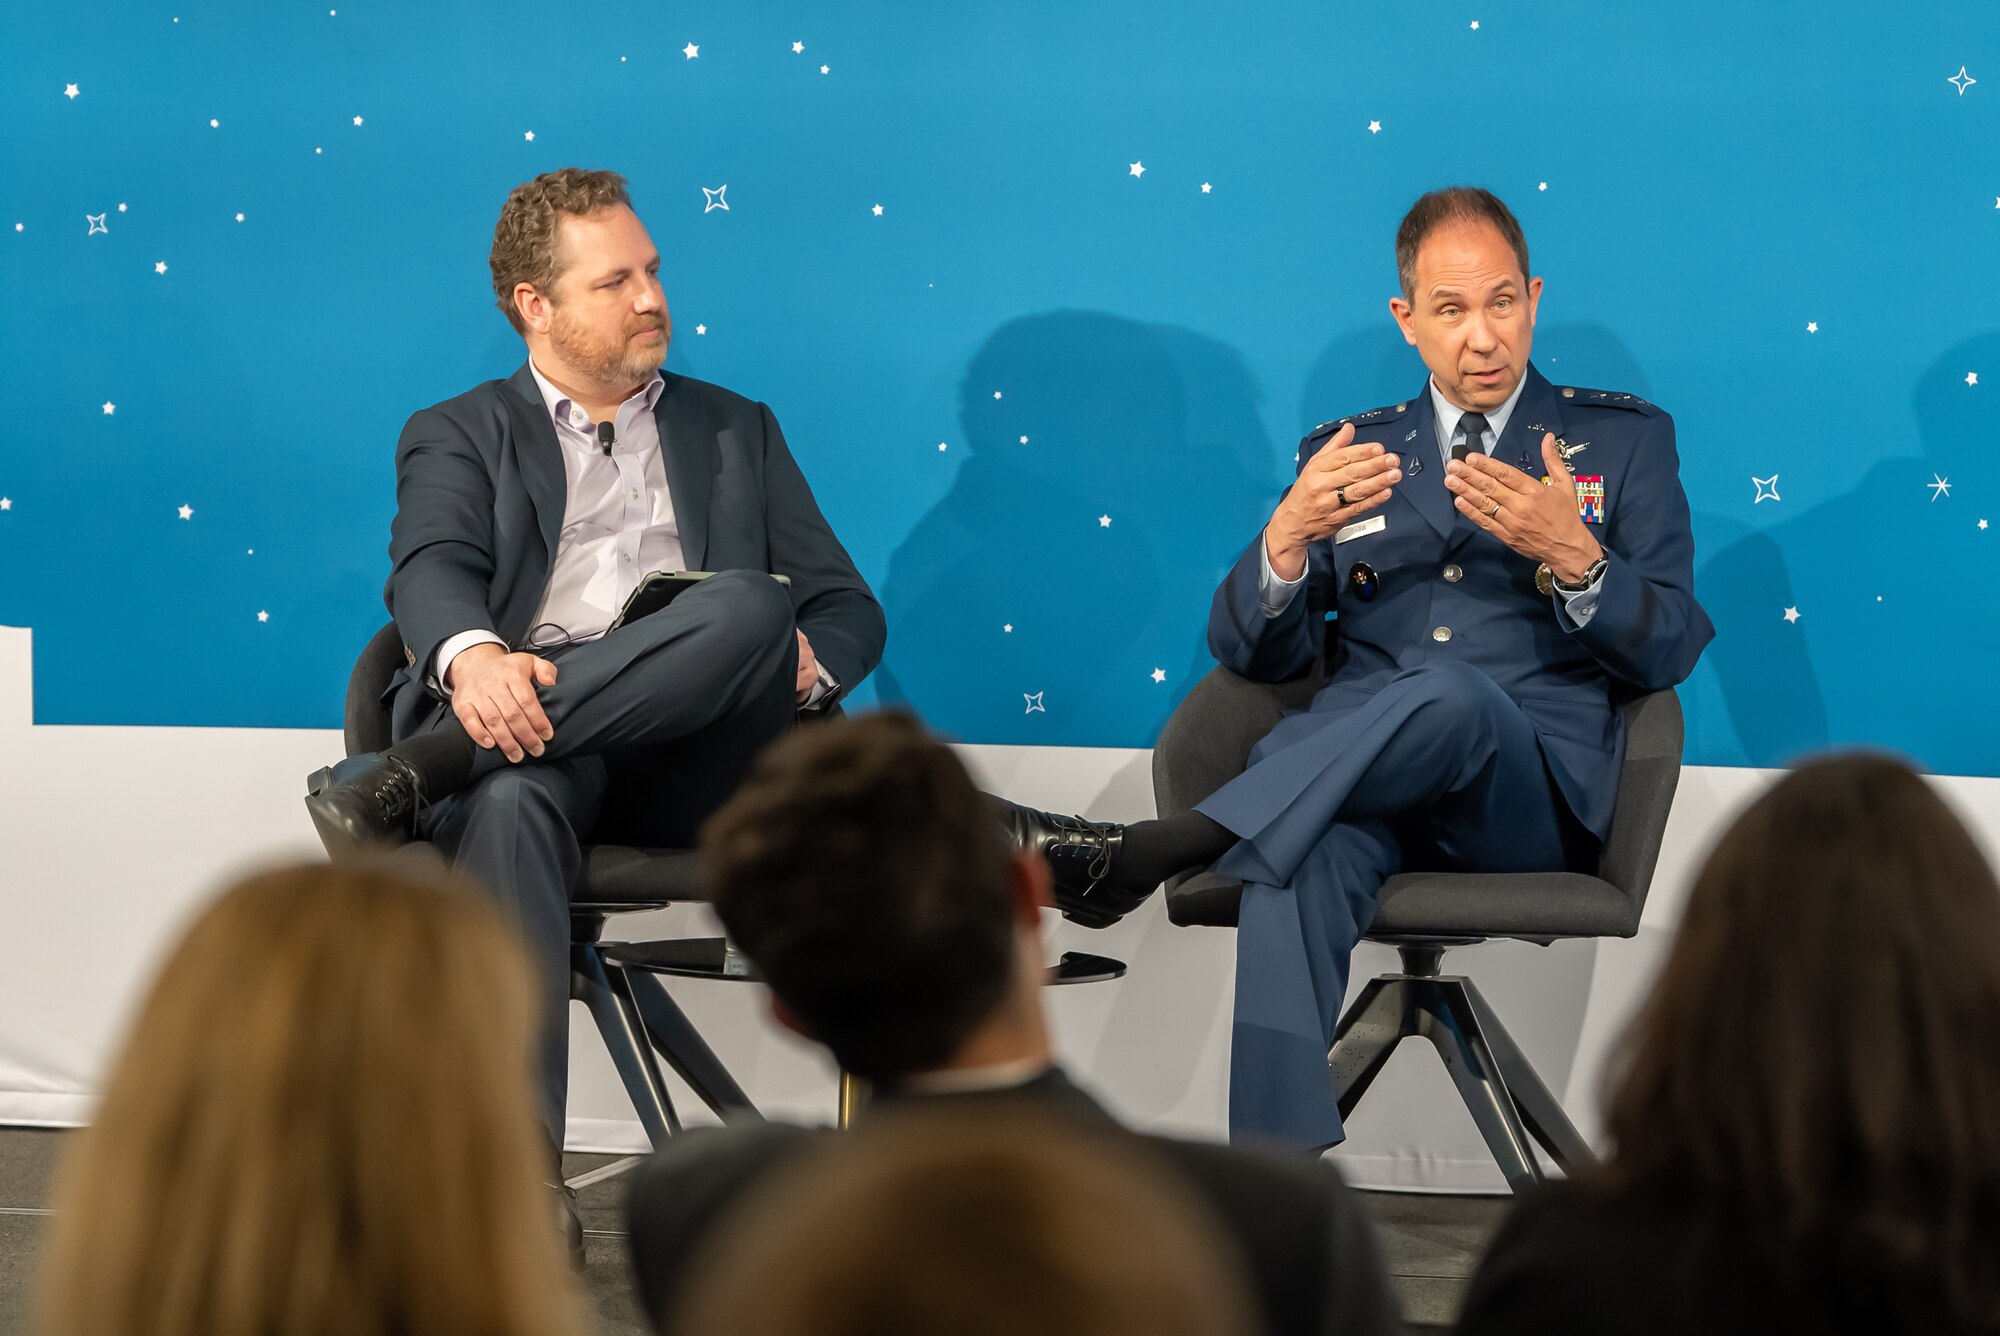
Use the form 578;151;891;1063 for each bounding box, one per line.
36;866;580;1336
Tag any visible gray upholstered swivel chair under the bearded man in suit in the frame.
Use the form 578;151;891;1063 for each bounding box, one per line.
342;622;758;1146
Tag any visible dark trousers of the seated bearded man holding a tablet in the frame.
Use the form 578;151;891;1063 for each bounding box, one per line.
420;572;798;1146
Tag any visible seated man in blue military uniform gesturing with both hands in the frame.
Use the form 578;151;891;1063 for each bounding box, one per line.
1012;188;1714;1146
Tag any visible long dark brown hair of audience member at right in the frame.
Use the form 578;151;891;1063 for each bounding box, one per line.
1604;756;2000;1332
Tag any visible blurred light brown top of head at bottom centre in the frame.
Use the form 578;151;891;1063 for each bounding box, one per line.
666;1104;1256;1336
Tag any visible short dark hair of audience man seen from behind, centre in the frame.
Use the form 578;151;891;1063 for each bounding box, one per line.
702;714;1014;1082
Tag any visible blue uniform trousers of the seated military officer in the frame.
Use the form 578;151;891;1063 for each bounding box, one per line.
1198;662;1594;1148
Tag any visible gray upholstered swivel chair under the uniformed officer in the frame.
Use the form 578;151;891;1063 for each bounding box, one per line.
1152;668;1682;1192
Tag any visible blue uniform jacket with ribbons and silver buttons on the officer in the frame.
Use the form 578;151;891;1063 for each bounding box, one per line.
1208;366;1714;838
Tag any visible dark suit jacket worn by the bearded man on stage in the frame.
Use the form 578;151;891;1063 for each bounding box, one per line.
384;364;886;738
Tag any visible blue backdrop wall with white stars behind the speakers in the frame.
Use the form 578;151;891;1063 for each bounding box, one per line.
0;0;2000;774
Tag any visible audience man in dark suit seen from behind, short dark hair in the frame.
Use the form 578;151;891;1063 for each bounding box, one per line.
628;714;1400;1336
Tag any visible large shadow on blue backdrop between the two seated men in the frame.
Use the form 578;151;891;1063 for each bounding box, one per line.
876;310;1272;746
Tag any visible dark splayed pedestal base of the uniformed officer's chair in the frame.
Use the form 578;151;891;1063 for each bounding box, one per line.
1326;942;1596;1192
